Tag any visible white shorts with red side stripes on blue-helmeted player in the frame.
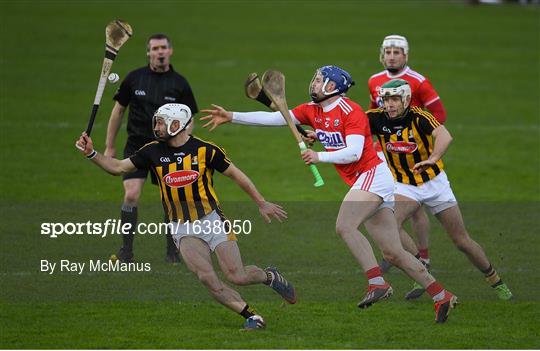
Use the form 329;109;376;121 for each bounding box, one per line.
351;162;394;210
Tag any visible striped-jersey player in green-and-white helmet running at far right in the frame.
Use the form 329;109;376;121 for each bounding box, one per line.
367;79;512;300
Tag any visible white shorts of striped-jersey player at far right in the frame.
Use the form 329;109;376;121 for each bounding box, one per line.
395;171;457;214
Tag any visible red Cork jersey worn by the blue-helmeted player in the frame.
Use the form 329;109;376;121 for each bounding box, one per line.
292;97;382;186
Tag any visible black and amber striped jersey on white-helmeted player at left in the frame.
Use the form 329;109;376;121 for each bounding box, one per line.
130;136;231;222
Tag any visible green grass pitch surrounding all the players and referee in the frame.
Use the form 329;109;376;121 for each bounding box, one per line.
0;1;540;349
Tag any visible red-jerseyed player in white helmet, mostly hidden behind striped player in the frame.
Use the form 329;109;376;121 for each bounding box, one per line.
368;35;446;300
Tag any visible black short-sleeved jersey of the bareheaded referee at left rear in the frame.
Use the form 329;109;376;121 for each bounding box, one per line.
113;65;199;139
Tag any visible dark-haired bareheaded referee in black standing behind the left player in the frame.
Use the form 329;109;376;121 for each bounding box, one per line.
104;33;198;263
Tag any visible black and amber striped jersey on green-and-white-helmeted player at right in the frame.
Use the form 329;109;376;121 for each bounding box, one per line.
366;106;443;185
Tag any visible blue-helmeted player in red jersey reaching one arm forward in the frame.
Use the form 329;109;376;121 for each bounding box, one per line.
201;66;457;323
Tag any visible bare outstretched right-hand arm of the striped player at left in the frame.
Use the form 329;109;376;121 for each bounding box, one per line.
223;164;287;223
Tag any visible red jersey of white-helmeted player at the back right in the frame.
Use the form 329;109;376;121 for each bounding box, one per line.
368;67;440;112
